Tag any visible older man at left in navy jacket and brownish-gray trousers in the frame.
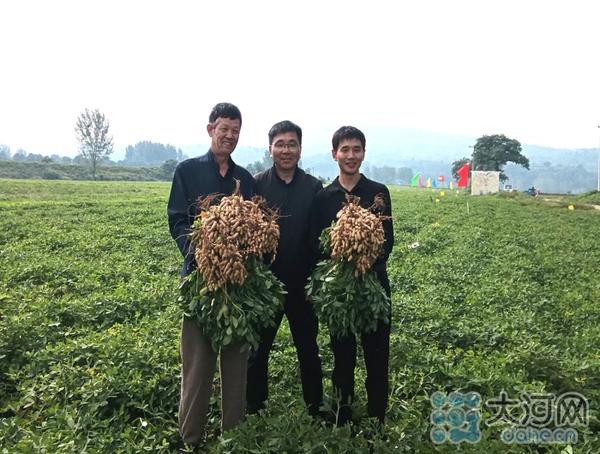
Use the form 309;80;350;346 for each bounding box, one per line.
167;103;254;445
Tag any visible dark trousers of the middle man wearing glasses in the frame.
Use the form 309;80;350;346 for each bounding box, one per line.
246;289;323;414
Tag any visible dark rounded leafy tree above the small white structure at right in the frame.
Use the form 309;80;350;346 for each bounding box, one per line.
472;134;529;181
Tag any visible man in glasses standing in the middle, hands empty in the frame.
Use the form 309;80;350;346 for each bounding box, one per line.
247;121;323;415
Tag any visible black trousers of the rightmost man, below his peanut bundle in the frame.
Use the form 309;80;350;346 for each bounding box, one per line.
331;322;390;424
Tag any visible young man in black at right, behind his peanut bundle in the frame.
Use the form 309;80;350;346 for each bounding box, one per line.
310;126;394;425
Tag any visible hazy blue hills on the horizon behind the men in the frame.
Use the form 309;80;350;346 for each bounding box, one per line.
182;126;598;193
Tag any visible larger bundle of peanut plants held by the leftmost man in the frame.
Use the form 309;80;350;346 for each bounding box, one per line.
180;182;285;351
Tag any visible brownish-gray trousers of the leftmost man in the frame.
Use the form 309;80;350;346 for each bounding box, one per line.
179;319;248;445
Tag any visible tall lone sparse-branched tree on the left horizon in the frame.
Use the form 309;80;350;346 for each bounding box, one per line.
75;109;113;180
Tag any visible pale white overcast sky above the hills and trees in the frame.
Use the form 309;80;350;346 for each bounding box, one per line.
0;0;600;156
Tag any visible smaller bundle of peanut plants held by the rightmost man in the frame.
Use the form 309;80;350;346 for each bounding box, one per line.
306;196;390;337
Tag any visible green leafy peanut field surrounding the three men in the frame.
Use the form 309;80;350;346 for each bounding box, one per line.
0;180;600;454
